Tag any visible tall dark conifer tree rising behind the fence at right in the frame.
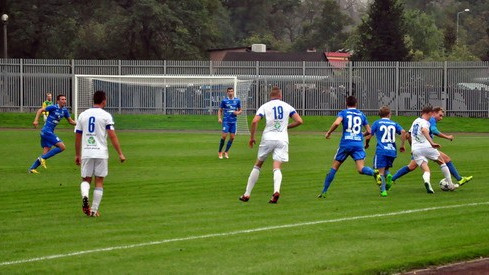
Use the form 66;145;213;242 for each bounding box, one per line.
353;0;411;61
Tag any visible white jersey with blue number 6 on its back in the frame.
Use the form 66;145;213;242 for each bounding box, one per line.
75;108;114;159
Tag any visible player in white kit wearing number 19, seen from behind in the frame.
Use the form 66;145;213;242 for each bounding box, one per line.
239;87;302;203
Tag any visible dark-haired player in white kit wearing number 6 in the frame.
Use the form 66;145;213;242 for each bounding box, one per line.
75;91;126;217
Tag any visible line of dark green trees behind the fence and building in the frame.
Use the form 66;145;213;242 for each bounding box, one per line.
0;0;489;61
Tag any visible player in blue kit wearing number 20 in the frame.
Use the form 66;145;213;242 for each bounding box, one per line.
365;106;406;197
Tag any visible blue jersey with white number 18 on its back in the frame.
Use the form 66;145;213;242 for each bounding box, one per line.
338;108;368;148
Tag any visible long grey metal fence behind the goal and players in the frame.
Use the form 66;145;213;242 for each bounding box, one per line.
0;59;489;117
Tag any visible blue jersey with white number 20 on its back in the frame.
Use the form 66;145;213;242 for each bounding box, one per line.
372;118;403;157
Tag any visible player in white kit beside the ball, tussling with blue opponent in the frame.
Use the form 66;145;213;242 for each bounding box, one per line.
398;106;459;194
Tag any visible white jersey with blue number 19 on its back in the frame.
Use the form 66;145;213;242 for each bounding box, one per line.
256;99;296;143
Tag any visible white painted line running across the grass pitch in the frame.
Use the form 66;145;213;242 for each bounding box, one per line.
0;201;489;266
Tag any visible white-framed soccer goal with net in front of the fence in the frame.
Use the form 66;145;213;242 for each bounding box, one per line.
73;75;252;133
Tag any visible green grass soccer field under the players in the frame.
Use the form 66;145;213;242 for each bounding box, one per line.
0;114;489;274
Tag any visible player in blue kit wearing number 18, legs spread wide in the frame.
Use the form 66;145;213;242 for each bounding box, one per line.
319;96;379;198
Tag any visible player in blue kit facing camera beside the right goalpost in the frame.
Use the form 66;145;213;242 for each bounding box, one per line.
217;88;243;159
